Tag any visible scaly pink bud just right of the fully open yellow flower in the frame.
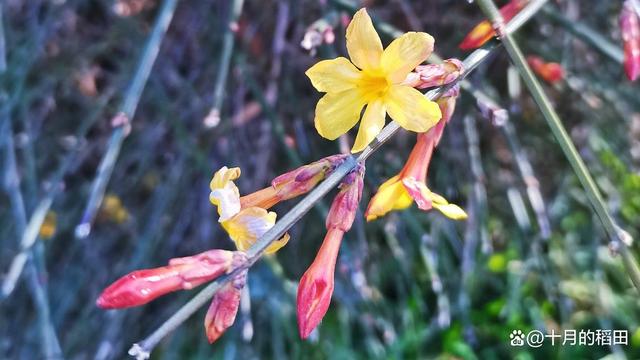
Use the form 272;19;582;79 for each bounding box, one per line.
404;59;464;89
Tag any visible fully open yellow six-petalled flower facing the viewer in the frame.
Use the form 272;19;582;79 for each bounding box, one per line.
306;9;441;152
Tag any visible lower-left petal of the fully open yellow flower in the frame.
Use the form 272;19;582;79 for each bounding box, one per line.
314;89;364;140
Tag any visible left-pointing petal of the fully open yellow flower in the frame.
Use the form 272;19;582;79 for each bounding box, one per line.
305;57;360;92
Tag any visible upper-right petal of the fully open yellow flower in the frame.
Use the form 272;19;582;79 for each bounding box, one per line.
380;32;434;84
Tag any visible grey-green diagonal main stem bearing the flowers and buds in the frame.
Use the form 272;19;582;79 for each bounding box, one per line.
129;1;544;359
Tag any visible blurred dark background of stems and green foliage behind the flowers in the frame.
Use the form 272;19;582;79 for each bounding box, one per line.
0;0;640;359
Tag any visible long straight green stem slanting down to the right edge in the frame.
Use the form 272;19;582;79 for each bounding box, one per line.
478;0;640;290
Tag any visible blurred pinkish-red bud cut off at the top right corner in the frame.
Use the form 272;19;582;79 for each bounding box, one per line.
620;0;640;81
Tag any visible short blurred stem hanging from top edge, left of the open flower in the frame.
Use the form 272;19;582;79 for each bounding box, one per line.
204;0;244;127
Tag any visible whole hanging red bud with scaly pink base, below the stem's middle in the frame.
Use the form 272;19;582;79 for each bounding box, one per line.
297;166;364;339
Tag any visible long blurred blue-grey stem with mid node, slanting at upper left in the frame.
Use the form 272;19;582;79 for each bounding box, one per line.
75;0;178;238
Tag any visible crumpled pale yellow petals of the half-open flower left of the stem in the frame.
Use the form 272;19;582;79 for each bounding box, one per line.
209;166;289;254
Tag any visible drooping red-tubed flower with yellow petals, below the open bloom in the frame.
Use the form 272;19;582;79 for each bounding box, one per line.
365;87;467;221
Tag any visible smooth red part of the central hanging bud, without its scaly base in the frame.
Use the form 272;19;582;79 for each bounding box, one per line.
297;228;344;339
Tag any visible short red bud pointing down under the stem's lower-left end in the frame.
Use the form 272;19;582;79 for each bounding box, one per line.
204;270;247;343
